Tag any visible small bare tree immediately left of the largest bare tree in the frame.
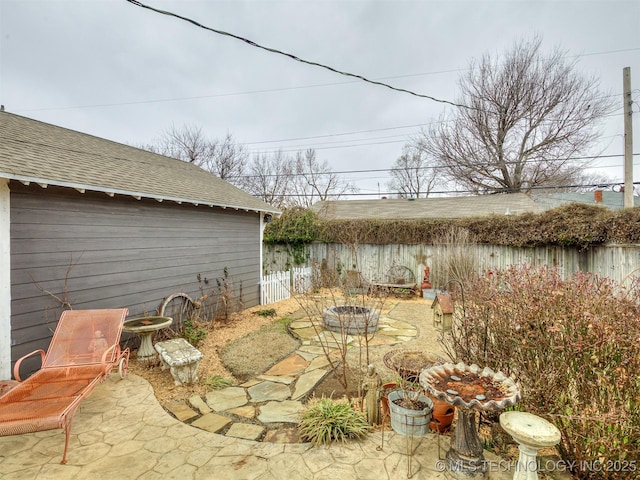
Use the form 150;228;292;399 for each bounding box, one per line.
387;145;438;198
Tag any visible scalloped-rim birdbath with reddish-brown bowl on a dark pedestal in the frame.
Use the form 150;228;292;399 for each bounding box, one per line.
420;362;520;479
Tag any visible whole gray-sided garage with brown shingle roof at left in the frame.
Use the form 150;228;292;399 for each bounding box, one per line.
0;112;279;379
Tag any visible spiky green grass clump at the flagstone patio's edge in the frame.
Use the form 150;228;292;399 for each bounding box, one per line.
298;397;369;445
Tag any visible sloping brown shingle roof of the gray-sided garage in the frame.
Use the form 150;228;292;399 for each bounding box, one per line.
0;112;279;213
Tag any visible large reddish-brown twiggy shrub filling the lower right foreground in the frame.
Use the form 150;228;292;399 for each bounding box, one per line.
444;266;640;479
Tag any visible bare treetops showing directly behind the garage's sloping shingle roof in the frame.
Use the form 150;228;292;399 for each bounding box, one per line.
143;125;248;186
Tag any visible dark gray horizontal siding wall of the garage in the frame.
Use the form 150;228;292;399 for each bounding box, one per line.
10;182;261;374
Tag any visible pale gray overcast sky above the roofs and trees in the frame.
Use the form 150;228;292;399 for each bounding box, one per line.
0;0;640;198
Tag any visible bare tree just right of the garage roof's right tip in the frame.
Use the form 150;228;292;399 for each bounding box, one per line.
288;149;357;207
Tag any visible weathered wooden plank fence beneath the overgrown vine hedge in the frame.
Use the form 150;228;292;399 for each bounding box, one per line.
263;242;640;283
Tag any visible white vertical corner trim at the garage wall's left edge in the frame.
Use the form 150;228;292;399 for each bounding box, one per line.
0;178;11;380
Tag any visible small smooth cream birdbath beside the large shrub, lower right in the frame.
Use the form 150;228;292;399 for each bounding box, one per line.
500;412;560;480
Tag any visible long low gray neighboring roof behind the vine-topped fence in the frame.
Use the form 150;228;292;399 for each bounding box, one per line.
311;193;543;220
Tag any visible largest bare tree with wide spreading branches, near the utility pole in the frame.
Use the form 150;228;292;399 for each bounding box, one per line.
417;37;613;193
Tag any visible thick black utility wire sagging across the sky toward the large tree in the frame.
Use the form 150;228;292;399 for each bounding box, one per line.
126;0;475;110
